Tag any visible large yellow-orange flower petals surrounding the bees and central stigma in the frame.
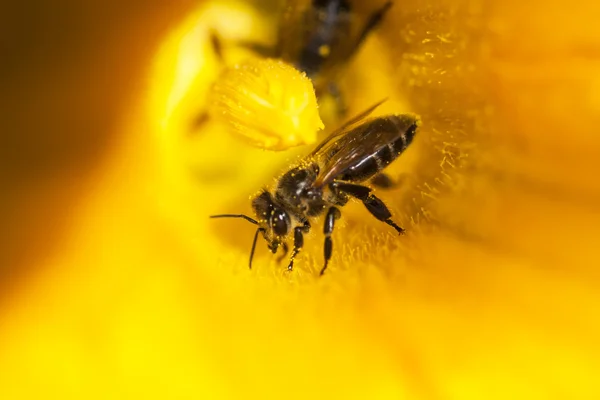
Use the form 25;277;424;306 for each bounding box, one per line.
0;0;600;399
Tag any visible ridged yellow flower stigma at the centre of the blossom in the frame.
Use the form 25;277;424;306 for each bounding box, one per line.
210;56;323;151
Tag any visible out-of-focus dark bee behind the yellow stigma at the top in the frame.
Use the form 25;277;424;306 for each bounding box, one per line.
239;0;392;114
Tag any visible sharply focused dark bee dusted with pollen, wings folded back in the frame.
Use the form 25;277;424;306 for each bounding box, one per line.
211;102;420;275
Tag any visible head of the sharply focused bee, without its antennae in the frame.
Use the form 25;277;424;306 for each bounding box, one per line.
252;190;291;242
